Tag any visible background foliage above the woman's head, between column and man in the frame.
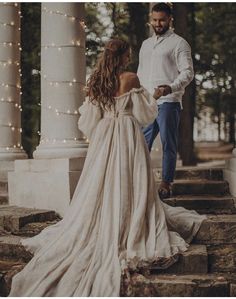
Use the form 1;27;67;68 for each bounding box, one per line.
85;2;149;72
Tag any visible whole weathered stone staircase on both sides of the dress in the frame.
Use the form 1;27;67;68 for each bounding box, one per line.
0;168;236;297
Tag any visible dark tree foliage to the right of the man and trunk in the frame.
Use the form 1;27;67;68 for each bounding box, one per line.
195;3;236;142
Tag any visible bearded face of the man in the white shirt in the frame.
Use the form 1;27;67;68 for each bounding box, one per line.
151;11;171;35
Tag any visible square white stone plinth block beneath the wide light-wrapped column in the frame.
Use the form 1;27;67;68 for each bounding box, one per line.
8;157;85;217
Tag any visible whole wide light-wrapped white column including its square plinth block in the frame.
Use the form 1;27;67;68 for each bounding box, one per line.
8;3;88;216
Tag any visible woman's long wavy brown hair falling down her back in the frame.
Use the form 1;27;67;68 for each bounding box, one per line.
87;39;130;110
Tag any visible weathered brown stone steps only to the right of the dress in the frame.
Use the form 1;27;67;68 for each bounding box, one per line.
121;168;236;297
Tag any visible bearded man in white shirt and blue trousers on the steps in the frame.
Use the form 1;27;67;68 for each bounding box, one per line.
138;3;194;199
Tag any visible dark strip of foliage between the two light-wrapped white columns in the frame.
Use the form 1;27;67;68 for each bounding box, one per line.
21;3;41;158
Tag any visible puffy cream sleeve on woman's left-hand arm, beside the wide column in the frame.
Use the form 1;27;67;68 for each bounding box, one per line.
78;98;102;139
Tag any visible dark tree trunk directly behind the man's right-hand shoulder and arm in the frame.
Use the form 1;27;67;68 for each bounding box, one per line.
173;3;196;165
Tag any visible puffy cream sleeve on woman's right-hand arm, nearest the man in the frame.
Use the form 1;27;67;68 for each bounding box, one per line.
131;87;158;127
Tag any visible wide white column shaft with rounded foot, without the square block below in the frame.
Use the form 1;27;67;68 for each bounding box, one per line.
34;3;88;159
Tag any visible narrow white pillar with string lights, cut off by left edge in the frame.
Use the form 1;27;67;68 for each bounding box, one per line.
0;3;27;161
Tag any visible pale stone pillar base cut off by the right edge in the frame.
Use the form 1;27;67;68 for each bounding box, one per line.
224;148;236;196
